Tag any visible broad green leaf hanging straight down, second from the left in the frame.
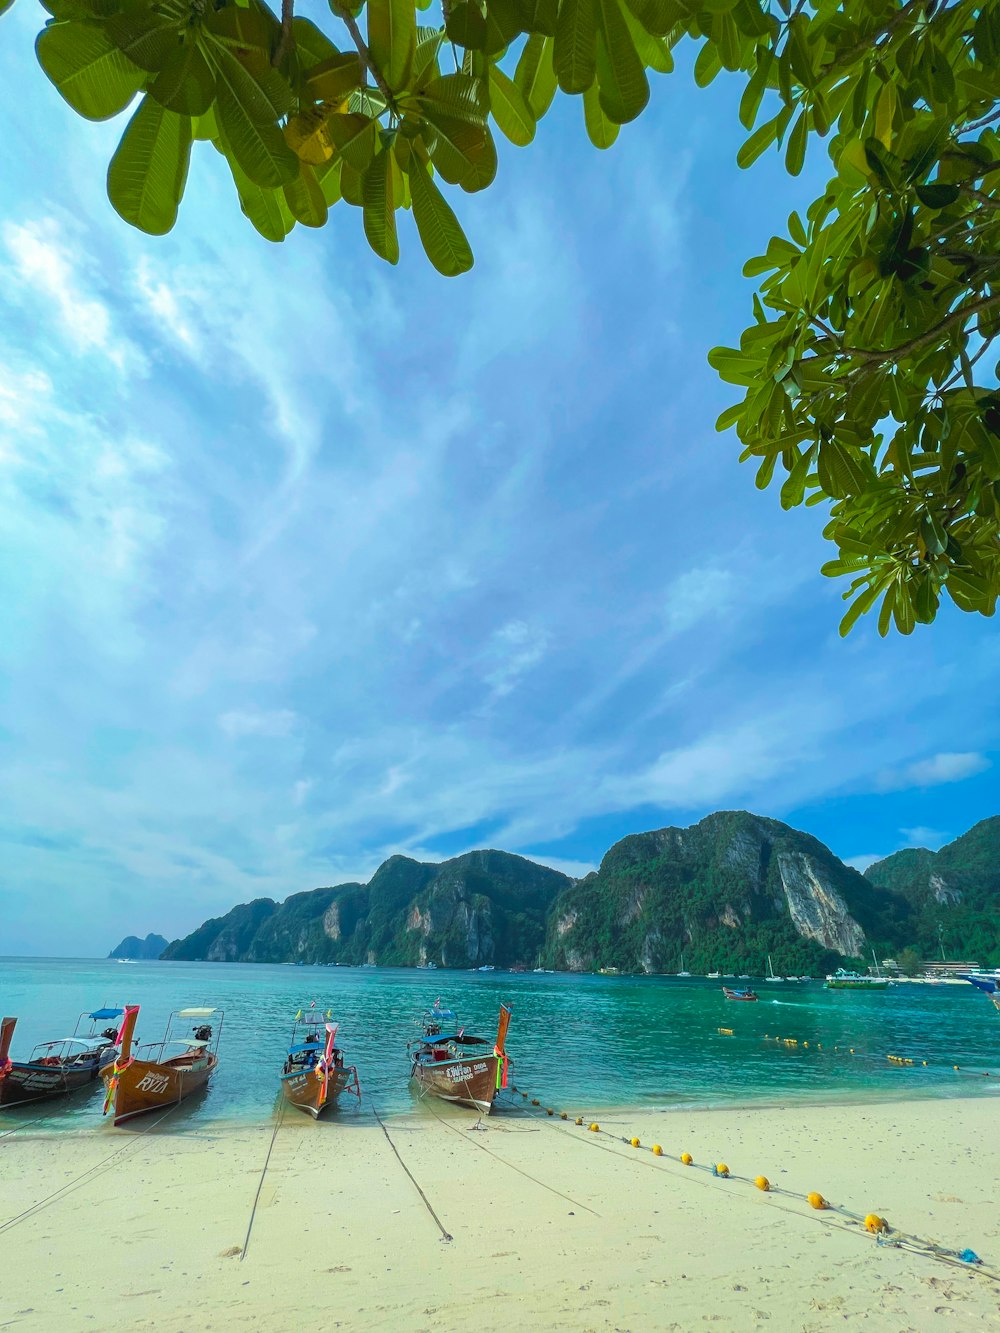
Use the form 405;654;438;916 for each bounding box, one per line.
108;97;191;236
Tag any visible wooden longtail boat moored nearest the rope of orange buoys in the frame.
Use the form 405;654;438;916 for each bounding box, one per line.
409;1000;512;1114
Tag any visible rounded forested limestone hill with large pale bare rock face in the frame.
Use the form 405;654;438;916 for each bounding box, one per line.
545;810;907;976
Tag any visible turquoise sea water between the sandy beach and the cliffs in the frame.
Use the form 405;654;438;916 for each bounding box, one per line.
0;958;1000;1130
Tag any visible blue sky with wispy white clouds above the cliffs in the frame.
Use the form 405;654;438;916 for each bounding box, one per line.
0;0;1000;954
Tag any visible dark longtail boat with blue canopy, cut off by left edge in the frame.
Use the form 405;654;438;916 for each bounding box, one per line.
0;1009;123;1106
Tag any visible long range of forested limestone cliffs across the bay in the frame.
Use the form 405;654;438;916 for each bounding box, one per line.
162;810;1000;976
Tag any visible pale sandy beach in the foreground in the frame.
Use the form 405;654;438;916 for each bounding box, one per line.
0;1097;1000;1333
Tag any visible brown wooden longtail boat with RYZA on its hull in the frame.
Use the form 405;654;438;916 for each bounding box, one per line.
101;1004;223;1125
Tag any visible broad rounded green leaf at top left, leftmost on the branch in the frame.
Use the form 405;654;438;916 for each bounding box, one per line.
35;23;145;120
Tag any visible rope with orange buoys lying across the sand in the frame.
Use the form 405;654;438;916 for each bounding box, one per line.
515;1088;1000;1284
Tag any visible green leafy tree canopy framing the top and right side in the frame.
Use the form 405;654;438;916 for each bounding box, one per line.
7;0;1000;635
